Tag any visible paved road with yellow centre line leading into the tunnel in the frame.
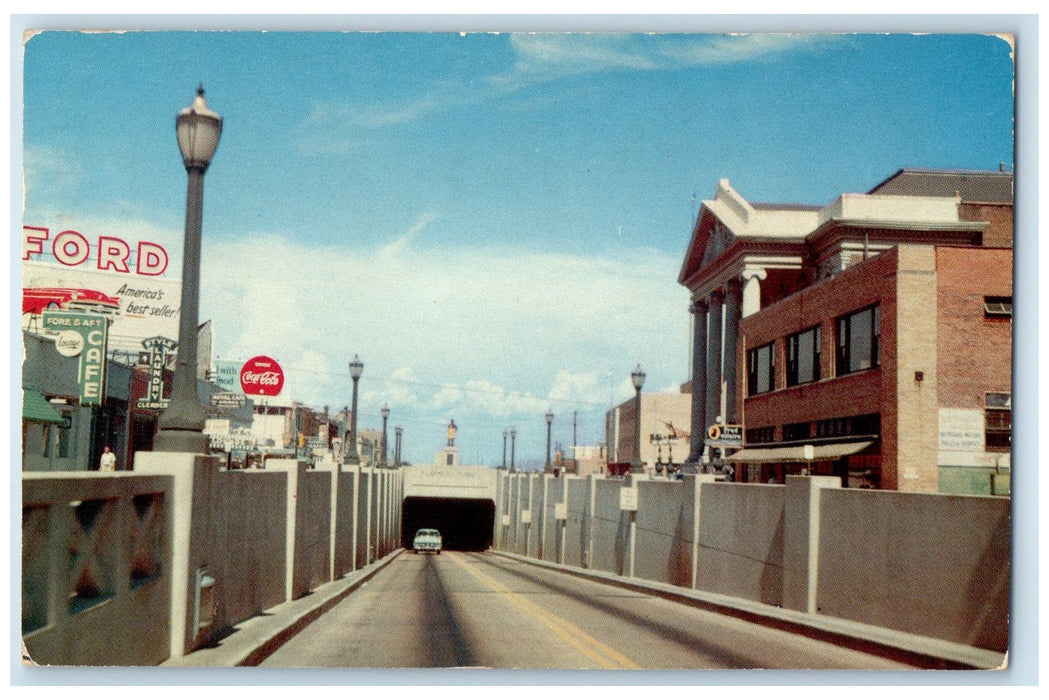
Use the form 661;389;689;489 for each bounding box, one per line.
261;551;923;670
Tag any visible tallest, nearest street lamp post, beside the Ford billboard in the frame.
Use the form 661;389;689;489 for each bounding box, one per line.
153;85;222;454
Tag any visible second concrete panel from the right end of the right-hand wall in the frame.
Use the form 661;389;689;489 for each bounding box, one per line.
697;483;785;606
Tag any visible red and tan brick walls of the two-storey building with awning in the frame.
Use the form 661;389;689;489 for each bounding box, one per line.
736;246;1012;491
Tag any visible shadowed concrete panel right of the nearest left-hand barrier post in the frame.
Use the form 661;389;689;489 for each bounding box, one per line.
209;469;287;630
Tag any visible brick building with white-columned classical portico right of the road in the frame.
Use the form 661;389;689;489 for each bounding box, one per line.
679;170;1012;493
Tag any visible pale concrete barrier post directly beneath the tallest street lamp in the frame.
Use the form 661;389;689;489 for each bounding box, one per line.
134;452;222;658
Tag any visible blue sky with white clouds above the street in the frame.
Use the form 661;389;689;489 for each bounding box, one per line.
16;31;1013;464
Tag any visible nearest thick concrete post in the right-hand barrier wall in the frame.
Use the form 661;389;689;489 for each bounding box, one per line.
783;476;841;613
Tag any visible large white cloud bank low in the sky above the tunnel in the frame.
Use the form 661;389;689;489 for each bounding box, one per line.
200;214;688;417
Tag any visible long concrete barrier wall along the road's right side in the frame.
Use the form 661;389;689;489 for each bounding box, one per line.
490;474;1010;652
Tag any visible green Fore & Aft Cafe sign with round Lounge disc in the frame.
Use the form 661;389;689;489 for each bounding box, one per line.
43;311;109;406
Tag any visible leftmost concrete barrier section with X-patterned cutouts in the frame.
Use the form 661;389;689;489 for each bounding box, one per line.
22;472;174;665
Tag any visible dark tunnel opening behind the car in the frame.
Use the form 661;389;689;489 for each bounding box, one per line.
401;496;495;552
